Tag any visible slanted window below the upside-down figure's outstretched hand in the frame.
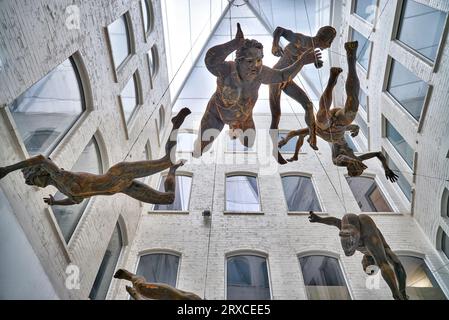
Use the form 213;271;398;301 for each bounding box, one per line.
346;177;391;212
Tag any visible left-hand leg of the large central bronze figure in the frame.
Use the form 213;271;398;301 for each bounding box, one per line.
193;101;224;158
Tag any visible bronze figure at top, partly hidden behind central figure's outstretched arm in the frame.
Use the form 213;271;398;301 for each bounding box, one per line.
270;26;337;164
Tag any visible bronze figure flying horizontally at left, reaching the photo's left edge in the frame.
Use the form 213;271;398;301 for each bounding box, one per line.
0;108;190;205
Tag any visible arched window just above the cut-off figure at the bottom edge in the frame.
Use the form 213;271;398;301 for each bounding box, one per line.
136;253;179;287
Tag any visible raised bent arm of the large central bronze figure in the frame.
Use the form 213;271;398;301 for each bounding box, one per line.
204;23;245;77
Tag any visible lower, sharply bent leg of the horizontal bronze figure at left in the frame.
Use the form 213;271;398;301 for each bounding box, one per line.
122;162;183;204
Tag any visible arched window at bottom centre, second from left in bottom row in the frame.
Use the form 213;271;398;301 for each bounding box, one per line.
226;256;271;300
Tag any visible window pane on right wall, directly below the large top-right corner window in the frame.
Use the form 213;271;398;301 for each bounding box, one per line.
387;60;429;121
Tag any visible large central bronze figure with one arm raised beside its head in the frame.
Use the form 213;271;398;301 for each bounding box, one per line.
193;23;321;157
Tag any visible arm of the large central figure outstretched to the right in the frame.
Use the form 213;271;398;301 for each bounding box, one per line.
261;49;321;84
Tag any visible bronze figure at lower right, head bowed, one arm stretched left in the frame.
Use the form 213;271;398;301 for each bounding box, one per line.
309;211;408;300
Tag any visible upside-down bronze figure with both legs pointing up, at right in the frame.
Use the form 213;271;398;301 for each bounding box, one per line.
279;41;398;182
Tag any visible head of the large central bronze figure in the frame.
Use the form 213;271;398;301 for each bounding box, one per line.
235;39;263;80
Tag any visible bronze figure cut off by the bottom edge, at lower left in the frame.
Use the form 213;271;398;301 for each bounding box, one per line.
114;269;202;300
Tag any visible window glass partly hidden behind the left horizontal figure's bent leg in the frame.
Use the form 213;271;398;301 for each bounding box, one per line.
154;176;192;211
